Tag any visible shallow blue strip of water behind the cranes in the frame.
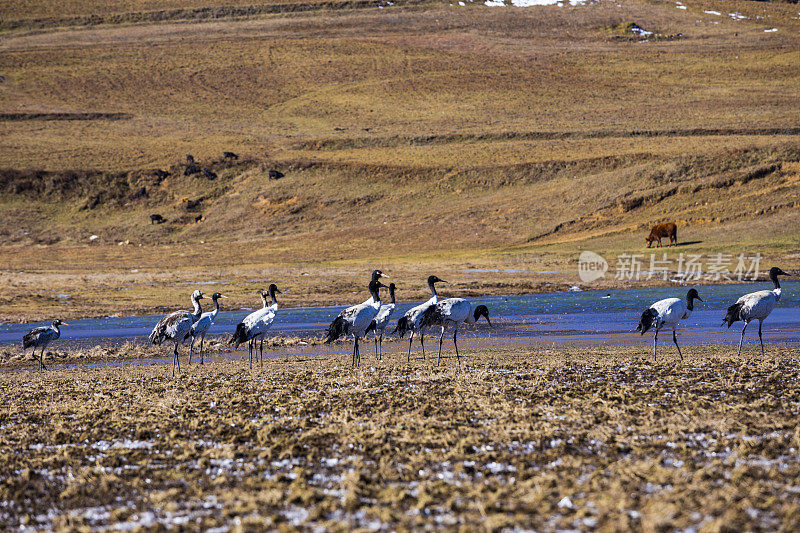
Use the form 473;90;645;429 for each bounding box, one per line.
0;281;800;345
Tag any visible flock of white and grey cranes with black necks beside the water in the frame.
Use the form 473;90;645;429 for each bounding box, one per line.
22;267;788;376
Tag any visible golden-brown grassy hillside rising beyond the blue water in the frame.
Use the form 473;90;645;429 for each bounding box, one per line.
0;0;800;320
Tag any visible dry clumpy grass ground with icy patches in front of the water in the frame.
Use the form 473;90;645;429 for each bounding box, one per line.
0;345;800;531
